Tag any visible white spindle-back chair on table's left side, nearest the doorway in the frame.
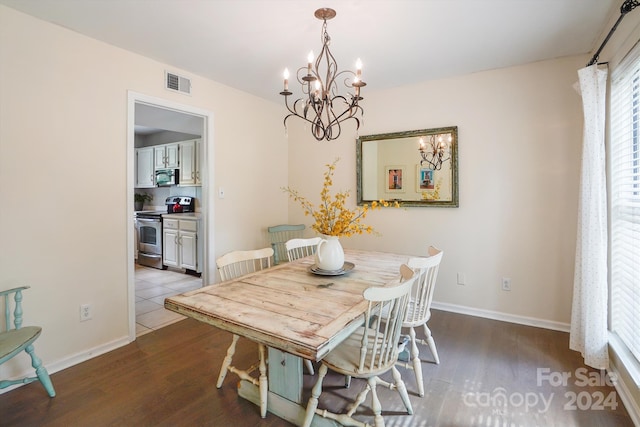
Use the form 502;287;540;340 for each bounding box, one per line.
216;248;273;418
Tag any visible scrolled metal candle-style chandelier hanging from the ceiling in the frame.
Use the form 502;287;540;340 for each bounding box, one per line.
280;8;366;141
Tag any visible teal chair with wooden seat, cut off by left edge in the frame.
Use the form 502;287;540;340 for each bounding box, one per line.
0;286;56;397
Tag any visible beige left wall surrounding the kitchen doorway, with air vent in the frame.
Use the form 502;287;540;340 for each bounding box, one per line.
0;6;288;377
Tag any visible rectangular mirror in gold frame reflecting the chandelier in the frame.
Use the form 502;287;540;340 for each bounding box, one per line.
356;126;458;208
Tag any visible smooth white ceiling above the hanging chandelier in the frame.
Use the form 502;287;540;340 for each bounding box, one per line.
0;0;622;102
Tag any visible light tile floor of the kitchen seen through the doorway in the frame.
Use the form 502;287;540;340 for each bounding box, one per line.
135;264;202;337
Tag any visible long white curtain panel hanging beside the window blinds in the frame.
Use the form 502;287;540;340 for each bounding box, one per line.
569;61;609;369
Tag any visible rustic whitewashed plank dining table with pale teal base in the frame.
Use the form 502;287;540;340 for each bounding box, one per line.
164;250;409;426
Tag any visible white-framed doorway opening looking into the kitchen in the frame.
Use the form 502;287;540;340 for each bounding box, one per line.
127;92;213;341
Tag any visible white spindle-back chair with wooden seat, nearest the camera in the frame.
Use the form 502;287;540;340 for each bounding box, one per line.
303;265;416;427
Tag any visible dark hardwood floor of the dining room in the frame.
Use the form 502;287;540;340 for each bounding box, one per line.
0;311;633;427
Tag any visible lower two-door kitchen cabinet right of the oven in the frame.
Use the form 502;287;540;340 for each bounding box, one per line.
162;217;202;273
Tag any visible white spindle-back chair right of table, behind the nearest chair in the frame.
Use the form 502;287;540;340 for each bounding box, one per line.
398;246;443;396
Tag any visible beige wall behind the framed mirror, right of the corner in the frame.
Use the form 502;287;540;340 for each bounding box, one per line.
289;56;586;329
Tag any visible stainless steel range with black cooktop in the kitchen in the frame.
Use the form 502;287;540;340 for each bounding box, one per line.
136;196;195;270
